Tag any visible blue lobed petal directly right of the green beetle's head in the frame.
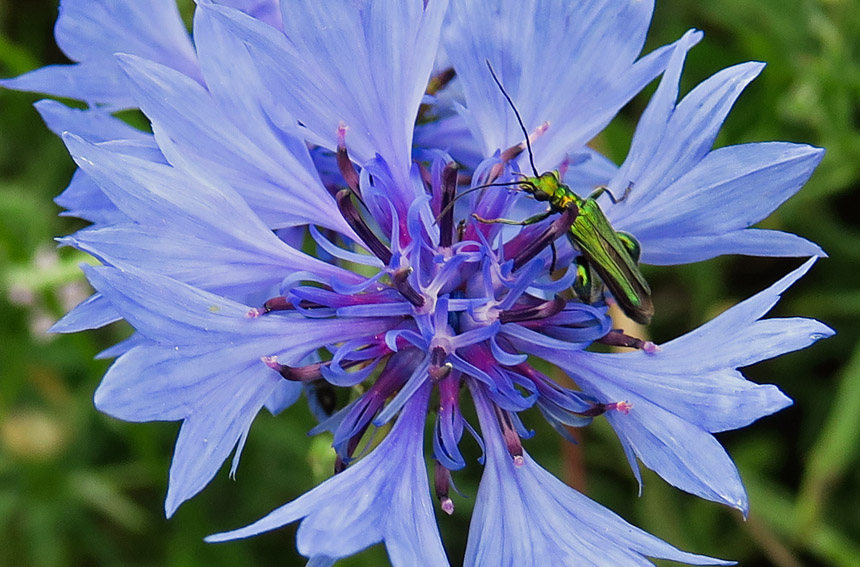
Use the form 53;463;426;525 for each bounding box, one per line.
604;48;823;264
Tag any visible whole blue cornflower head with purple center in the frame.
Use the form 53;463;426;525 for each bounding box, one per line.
3;0;832;566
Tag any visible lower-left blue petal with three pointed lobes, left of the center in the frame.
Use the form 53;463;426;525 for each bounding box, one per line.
85;267;390;515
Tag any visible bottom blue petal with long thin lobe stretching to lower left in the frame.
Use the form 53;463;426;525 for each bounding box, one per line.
206;387;448;567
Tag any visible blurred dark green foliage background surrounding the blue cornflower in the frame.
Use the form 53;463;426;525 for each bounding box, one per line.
0;0;860;567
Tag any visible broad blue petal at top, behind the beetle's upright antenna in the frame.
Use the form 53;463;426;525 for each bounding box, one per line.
445;0;692;171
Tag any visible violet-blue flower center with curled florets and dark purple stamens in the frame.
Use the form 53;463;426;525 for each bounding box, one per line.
248;142;640;506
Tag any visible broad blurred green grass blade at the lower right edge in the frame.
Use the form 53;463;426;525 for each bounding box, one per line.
793;347;860;541
